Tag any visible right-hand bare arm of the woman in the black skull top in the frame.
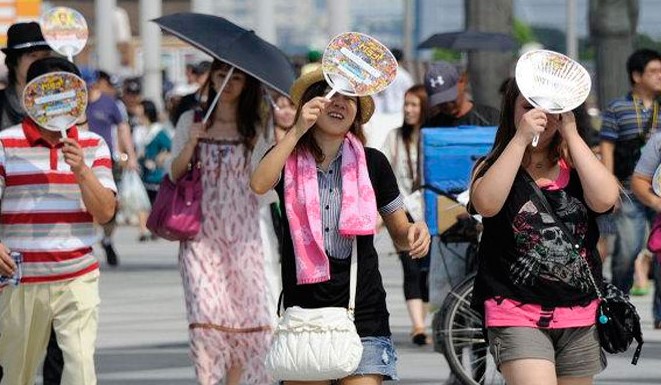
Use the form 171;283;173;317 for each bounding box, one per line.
560;112;619;213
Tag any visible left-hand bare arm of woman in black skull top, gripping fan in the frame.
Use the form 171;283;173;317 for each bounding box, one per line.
470;110;547;217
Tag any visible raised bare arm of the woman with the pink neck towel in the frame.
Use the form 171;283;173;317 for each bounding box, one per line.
250;97;329;195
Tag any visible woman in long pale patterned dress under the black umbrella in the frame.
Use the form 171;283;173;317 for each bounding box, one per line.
170;57;272;385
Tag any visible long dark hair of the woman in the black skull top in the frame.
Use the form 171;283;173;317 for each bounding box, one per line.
471;79;562;187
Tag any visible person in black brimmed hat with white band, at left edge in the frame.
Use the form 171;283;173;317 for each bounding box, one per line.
0;22;52;130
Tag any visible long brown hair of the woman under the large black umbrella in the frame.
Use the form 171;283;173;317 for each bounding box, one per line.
202;60;262;150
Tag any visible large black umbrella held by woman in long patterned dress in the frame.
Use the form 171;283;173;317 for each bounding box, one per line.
152;12;296;95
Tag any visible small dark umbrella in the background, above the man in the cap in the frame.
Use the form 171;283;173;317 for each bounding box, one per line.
418;30;516;51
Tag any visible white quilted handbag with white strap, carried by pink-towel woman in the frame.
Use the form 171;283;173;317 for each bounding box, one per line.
266;240;363;381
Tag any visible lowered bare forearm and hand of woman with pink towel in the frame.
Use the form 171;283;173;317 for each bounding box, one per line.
383;209;431;258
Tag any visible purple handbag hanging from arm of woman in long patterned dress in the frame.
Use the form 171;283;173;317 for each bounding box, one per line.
147;147;202;241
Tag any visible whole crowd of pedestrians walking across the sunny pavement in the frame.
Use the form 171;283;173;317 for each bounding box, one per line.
0;16;661;385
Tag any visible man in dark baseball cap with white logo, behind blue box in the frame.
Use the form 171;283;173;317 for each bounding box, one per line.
423;61;500;127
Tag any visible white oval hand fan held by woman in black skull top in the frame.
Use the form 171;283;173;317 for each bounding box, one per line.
514;50;592;147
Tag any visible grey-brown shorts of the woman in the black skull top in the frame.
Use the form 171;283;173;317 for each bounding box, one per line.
488;326;606;377
